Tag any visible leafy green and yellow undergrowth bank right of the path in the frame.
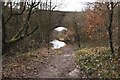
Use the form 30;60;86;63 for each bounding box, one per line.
76;47;120;78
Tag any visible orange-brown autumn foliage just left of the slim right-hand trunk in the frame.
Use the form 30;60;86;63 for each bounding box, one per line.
82;9;107;45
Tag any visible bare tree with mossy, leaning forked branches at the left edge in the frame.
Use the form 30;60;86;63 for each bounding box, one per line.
2;1;40;52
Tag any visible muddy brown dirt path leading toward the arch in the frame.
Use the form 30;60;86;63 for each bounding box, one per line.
36;46;78;78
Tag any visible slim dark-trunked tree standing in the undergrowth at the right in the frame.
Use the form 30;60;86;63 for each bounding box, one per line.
87;0;118;55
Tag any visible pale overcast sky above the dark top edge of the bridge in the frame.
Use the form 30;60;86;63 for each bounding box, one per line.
3;0;118;12
